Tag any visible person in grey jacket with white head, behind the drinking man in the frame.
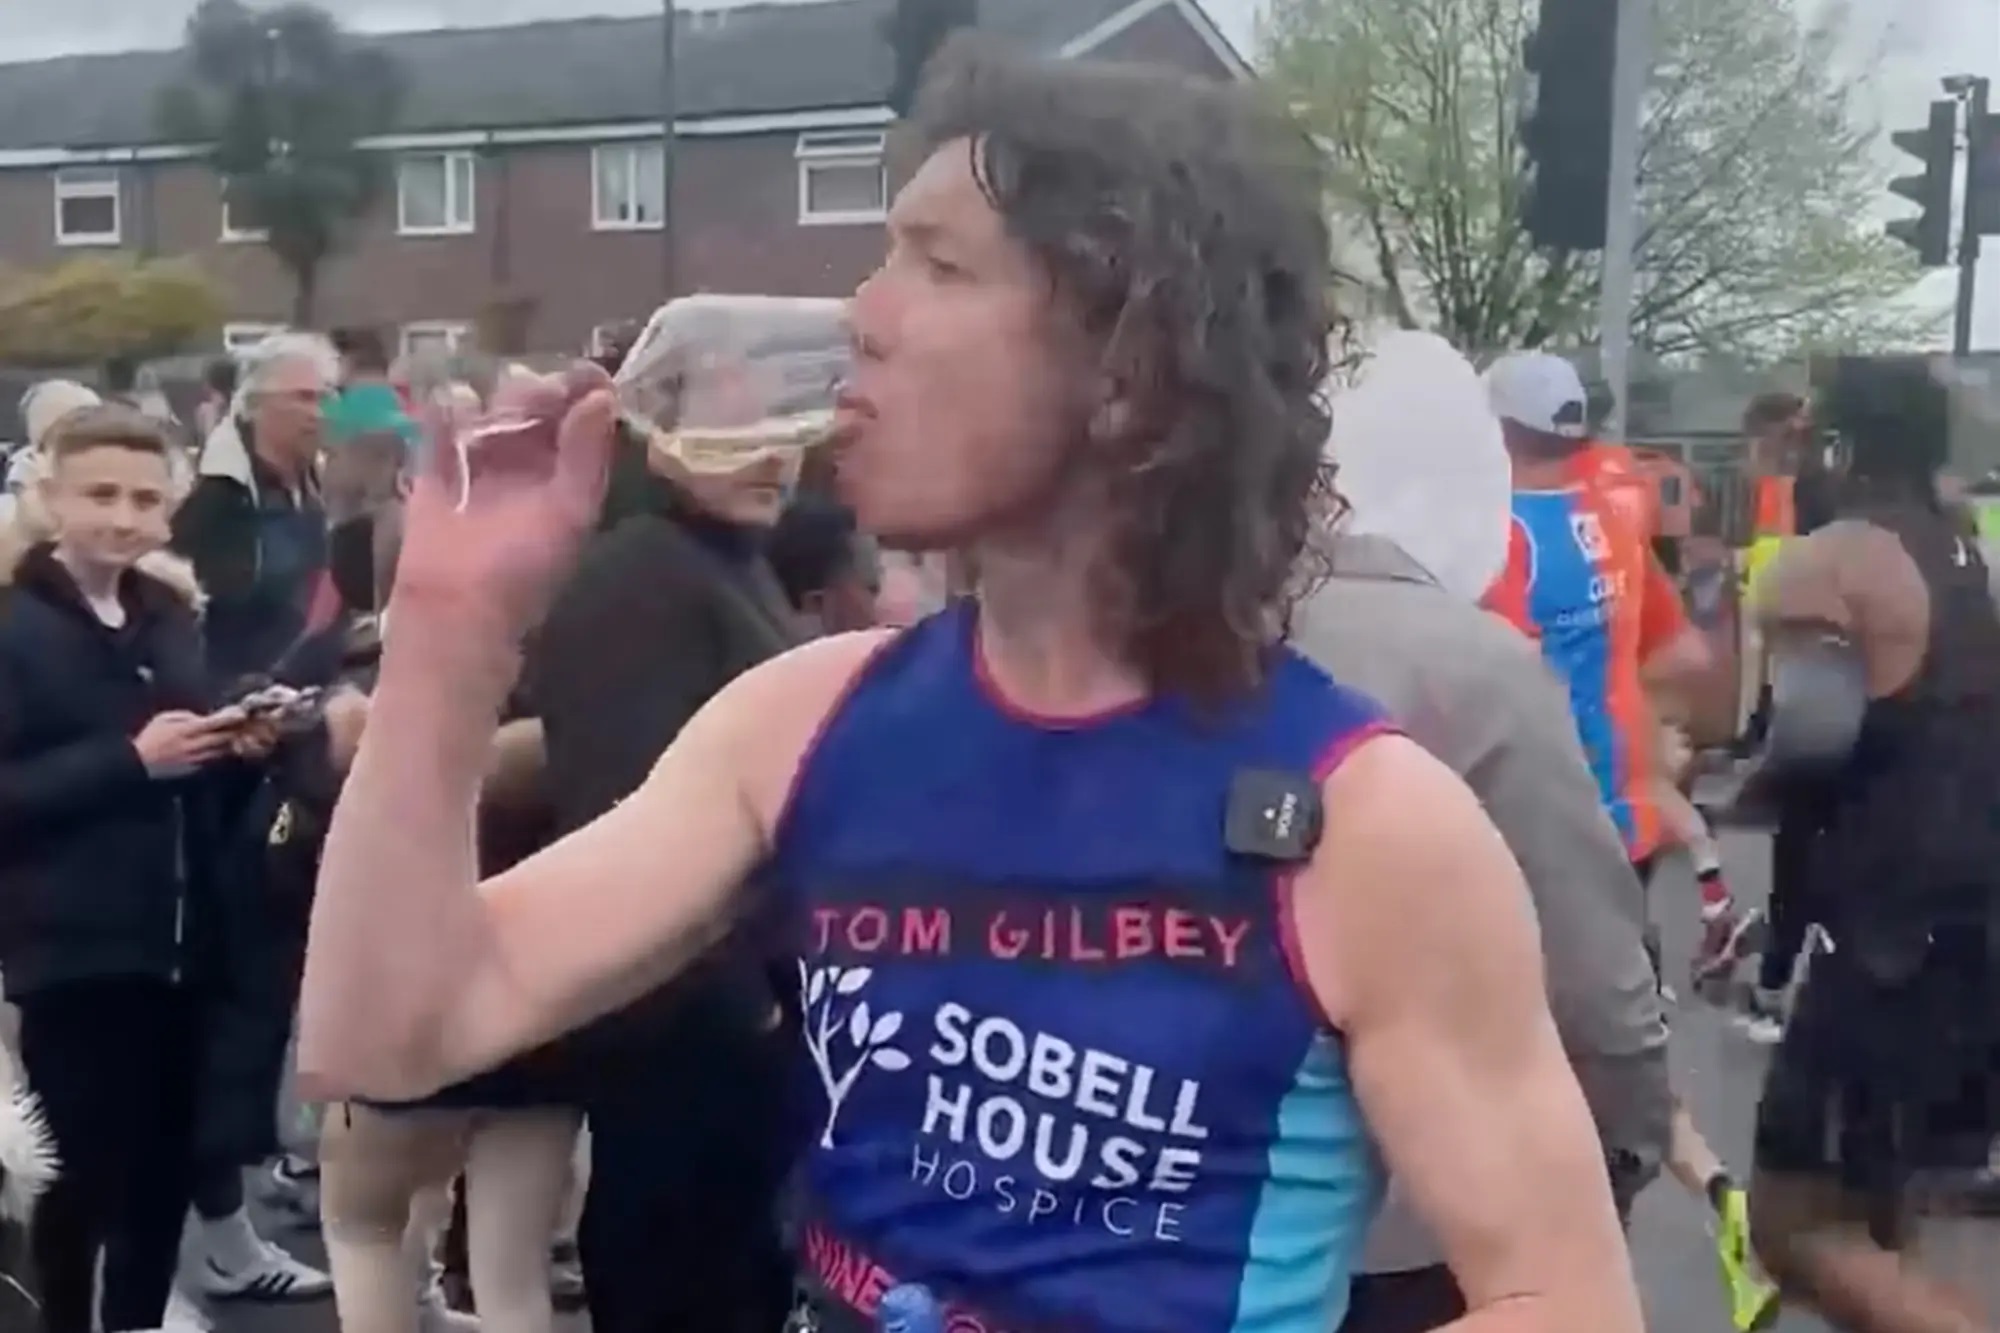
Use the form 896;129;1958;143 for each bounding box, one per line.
1292;334;1672;1333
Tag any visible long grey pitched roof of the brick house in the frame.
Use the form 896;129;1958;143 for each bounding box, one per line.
0;0;1132;150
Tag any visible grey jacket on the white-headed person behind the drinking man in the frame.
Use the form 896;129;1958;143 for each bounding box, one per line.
1292;536;1672;1273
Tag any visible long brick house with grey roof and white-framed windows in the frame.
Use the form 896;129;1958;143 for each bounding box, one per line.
0;0;1248;350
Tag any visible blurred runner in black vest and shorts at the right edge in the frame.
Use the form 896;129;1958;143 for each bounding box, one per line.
1750;358;2000;1333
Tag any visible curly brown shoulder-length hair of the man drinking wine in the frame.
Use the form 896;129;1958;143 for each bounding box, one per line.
910;34;1336;705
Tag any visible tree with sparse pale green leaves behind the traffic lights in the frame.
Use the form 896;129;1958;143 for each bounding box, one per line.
1264;0;1940;360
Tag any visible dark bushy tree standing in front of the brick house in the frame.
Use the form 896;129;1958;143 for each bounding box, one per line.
160;0;402;328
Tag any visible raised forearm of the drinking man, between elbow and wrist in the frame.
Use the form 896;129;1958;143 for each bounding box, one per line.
300;622;516;1097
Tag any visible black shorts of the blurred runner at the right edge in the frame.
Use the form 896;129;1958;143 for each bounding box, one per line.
1756;928;2000;1193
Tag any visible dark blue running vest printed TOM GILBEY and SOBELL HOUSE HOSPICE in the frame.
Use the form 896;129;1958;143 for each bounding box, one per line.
770;602;1382;1333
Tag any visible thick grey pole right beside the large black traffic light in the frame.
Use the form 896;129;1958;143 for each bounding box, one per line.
1598;0;1654;440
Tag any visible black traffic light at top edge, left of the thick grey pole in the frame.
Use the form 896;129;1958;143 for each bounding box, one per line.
1520;0;1618;250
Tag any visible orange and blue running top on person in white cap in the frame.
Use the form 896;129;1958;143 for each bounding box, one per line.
1486;456;1688;861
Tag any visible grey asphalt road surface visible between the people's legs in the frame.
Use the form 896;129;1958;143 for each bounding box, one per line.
220;835;2000;1333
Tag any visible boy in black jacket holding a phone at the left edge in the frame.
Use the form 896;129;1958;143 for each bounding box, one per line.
0;406;268;1333
